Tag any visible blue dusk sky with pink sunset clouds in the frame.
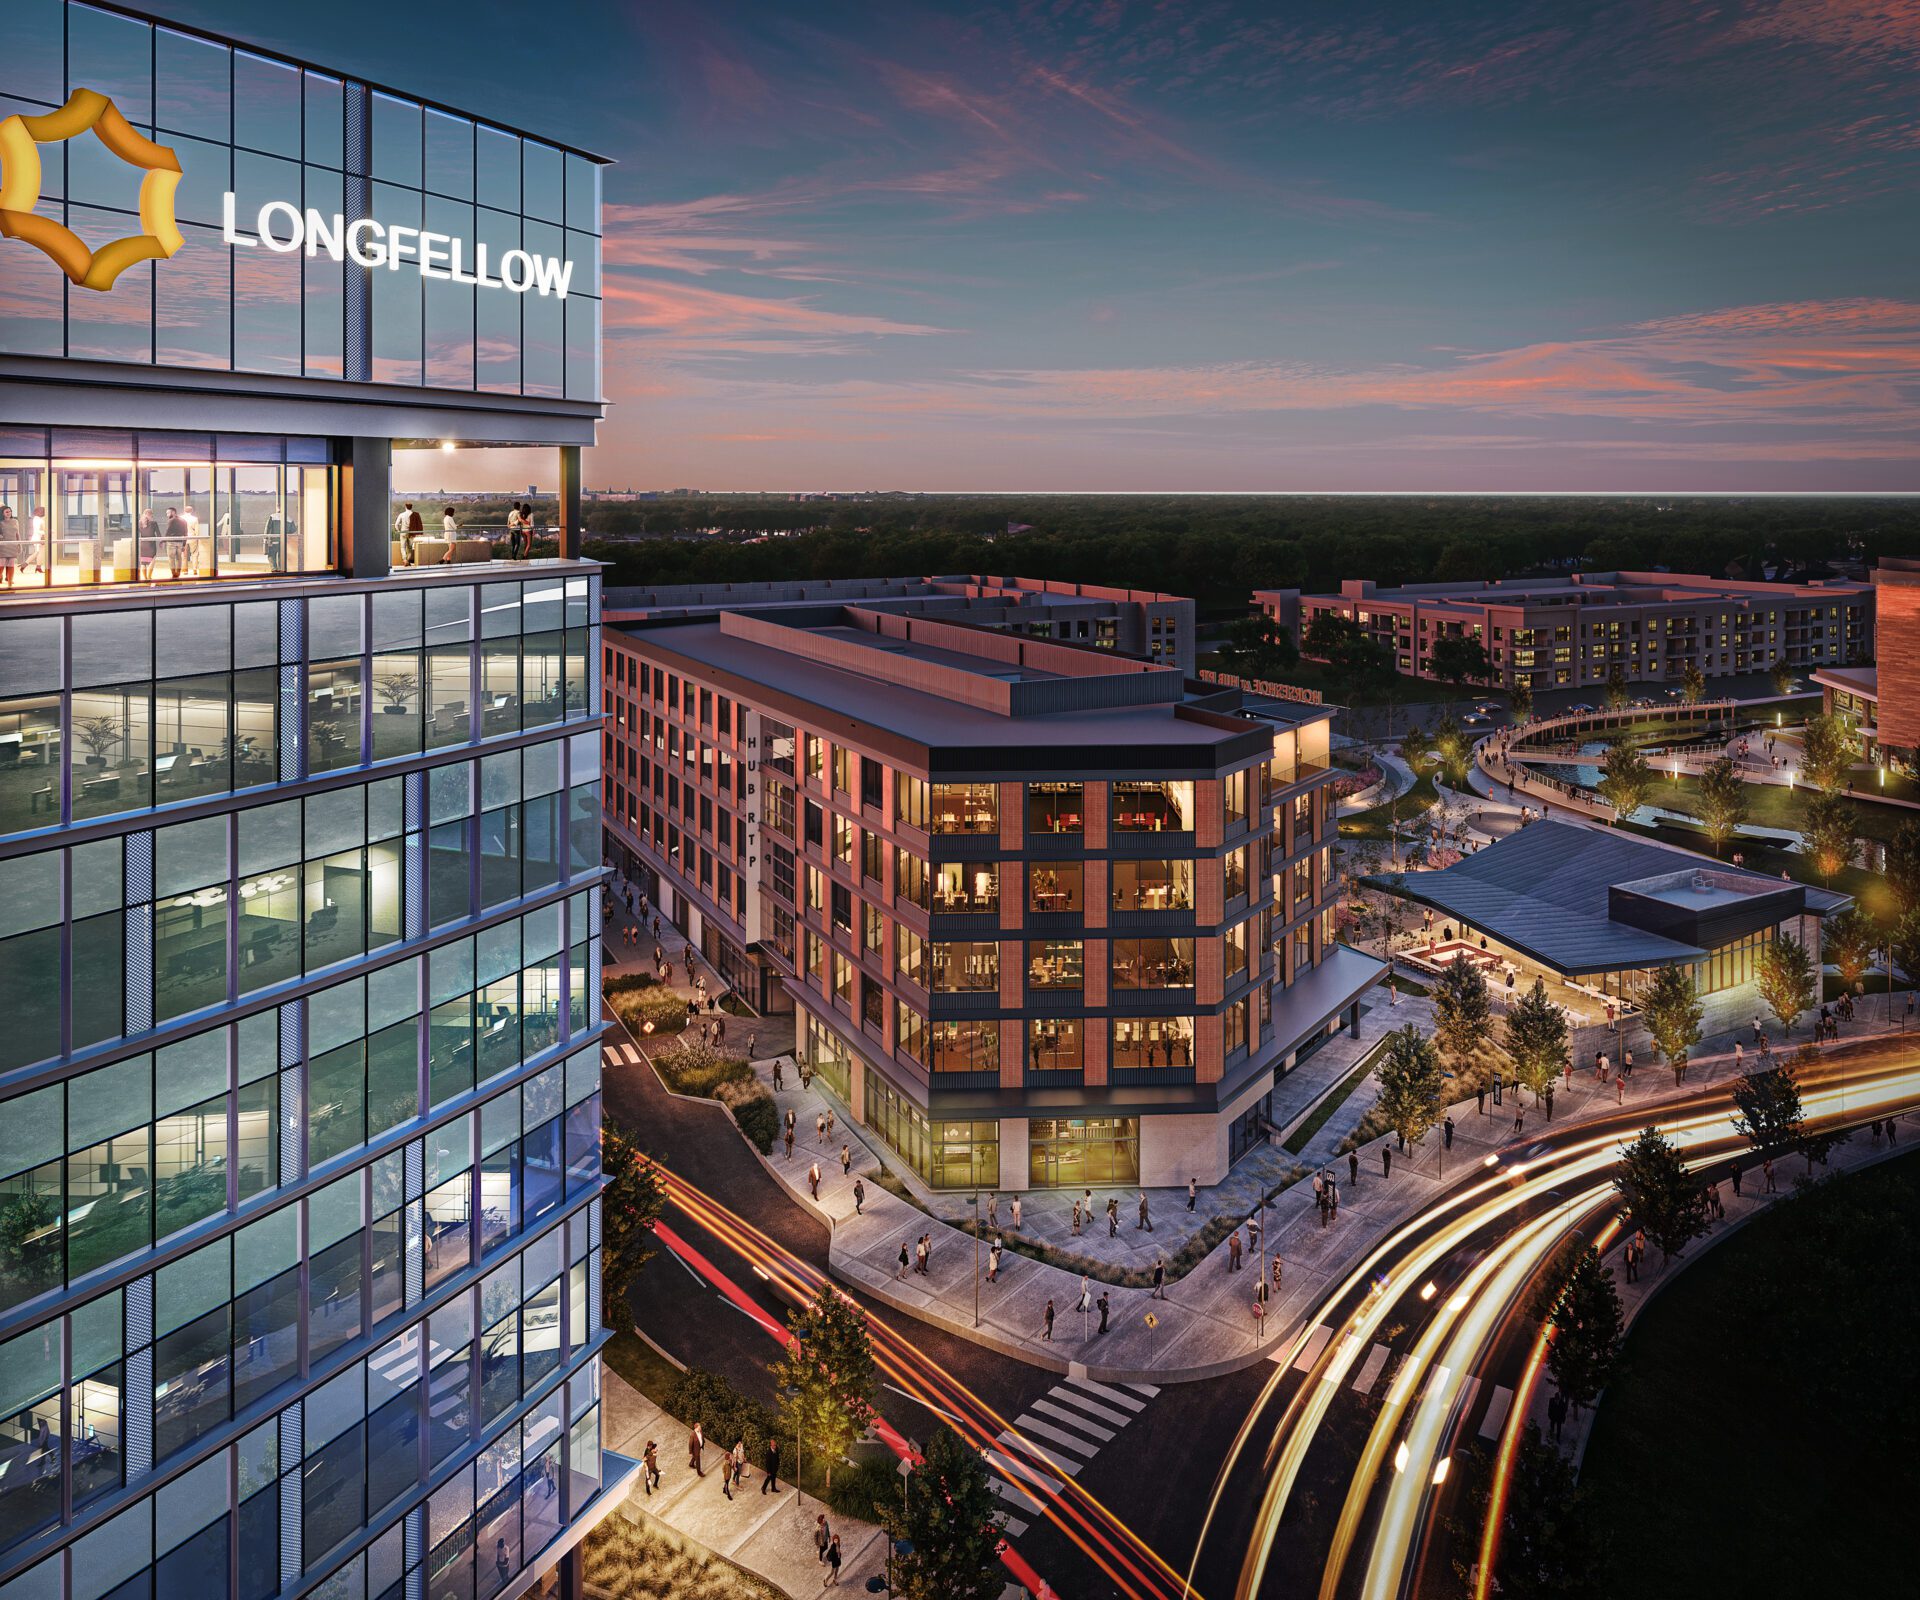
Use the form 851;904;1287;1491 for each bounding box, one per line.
159;0;1920;490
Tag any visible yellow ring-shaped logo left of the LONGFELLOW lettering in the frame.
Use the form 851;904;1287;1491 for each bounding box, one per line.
0;88;186;290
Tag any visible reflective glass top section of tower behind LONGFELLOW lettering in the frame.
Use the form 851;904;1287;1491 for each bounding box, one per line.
0;0;601;411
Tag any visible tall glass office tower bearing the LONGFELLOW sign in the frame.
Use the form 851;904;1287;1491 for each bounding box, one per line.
0;0;614;1600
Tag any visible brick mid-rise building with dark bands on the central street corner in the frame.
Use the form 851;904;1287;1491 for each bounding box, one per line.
605;597;1380;1189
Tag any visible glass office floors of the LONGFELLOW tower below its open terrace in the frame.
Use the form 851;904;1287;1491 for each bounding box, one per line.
0;565;605;1600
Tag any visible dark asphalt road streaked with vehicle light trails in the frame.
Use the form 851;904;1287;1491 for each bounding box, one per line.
605;991;1916;1600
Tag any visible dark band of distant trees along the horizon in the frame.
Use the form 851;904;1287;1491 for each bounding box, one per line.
572;494;1920;605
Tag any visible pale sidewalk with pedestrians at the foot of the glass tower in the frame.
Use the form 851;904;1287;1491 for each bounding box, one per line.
601;1368;887;1600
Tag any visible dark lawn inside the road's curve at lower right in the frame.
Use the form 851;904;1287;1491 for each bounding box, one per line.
1580;1133;1920;1600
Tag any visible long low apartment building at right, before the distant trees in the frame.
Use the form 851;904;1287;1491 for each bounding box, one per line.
1254;572;1874;693
